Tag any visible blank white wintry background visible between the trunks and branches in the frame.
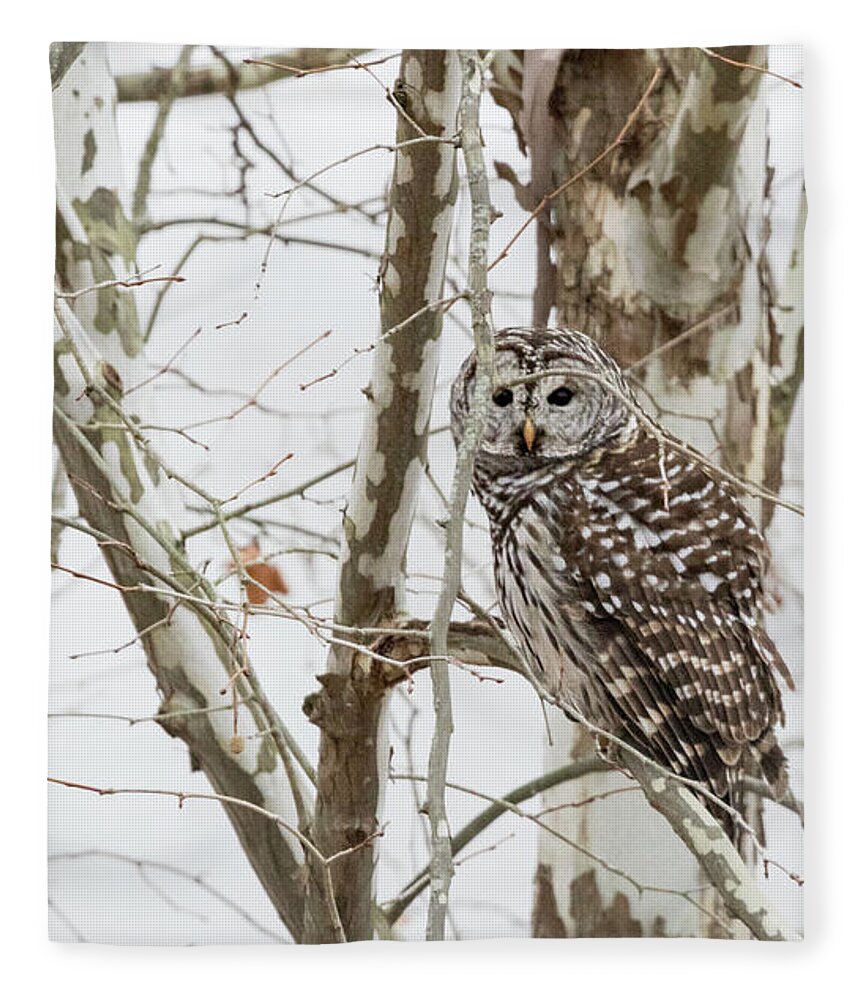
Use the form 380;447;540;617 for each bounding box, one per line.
48;45;803;944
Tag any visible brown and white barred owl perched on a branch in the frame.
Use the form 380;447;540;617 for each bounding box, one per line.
451;329;792;834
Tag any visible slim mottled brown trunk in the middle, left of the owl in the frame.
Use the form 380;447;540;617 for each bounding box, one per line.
306;51;459;941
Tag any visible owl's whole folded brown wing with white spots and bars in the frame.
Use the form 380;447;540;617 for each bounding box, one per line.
564;444;790;795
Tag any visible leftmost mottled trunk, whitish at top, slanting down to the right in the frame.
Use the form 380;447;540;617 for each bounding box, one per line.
54;45;304;939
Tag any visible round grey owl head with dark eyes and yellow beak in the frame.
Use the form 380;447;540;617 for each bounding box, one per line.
451;328;638;469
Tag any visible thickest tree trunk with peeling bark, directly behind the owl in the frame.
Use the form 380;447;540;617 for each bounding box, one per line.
494;48;797;937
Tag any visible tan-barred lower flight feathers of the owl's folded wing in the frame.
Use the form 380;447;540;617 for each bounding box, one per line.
576;577;782;796
